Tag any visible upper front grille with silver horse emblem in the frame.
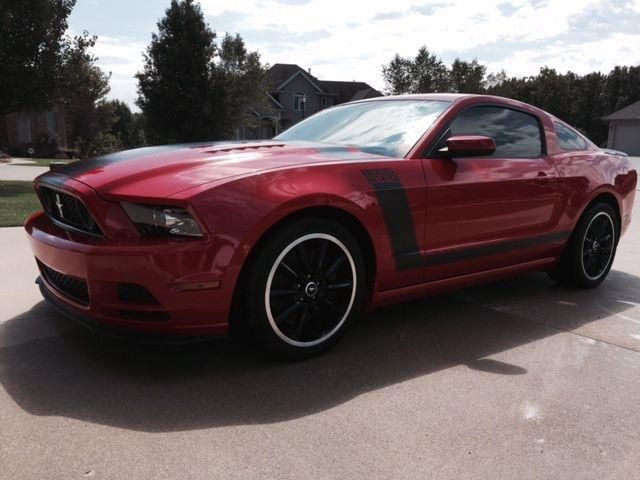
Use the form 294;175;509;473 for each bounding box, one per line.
38;186;102;235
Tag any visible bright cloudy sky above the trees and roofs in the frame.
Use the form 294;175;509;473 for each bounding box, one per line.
69;0;640;107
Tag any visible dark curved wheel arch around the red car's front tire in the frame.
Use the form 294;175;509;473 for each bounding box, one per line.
229;205;377;332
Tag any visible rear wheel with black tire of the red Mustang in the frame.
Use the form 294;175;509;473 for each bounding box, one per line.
549;203;620;288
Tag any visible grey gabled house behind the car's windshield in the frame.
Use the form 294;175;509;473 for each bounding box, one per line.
238;63;382;139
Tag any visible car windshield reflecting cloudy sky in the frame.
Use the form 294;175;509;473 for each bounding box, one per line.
275;100;451;158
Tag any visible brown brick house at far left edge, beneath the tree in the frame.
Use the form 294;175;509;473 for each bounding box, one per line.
0;108;67;156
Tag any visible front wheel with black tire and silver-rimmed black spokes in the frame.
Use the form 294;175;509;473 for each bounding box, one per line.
245;217;365;359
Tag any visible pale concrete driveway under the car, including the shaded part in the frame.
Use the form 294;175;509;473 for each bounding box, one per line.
0;190;640;480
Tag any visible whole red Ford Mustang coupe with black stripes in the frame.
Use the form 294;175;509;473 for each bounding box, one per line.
26;94;637;358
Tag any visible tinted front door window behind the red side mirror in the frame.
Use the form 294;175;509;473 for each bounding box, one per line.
443;107;544;158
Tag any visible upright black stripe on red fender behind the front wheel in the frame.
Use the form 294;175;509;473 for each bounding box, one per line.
362;168;424;271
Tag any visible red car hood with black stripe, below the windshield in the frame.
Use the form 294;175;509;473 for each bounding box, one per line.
43;141;384;198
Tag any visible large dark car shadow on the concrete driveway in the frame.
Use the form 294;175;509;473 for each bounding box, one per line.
0;271;640;432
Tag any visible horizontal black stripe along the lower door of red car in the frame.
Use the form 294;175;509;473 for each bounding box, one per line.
427;232;571;266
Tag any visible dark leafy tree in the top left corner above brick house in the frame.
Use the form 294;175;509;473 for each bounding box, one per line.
0;0;76;114
